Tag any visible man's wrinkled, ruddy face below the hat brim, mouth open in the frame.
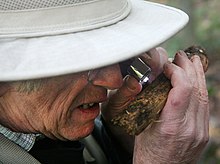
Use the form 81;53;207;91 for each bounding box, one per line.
0;65;122;140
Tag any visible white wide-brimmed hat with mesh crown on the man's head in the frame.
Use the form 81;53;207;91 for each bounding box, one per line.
0;0;188;81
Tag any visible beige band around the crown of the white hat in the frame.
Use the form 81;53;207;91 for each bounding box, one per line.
0;0;131;38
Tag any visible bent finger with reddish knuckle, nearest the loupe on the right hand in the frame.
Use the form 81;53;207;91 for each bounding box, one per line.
162;62;193;119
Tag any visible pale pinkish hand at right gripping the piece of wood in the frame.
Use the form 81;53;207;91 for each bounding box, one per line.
134;51;209;164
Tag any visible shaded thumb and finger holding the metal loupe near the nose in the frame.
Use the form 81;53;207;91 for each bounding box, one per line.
102;47;167;121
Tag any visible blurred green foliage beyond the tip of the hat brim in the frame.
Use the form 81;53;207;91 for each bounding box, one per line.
151;0;220;56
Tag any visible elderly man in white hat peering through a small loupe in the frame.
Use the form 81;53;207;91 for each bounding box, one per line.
0;0;209;164
